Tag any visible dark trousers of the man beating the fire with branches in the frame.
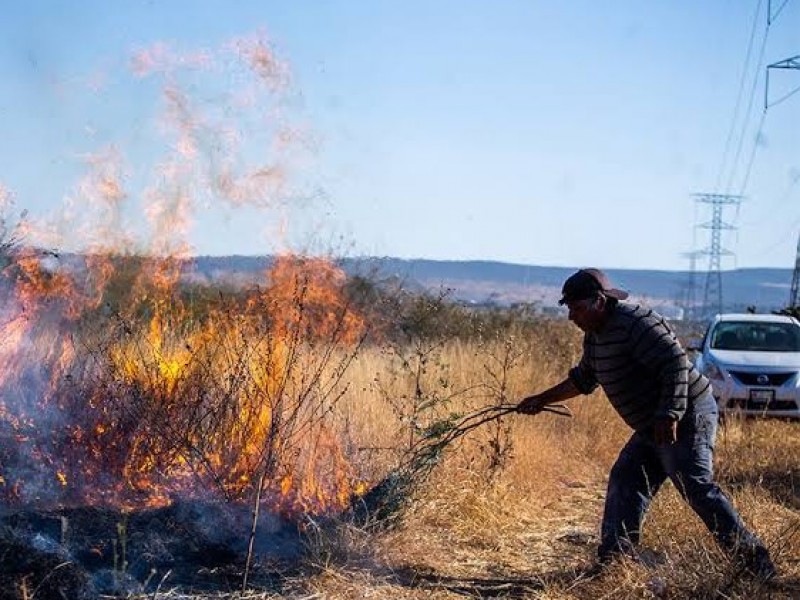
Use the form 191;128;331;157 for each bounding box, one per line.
598;394;761;561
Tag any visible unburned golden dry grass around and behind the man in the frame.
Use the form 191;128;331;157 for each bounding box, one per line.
128;323;800;600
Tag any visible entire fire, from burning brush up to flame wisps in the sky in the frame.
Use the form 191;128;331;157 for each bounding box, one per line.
0;32;366;513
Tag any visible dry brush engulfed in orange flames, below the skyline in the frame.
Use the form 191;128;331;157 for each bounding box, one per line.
0;251;365;514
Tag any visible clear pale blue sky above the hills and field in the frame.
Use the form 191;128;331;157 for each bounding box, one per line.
0;0;800;269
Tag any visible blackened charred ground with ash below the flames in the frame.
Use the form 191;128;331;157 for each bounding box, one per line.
0;501;305;600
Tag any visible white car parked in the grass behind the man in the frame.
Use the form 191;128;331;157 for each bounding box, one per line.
689;314;800;418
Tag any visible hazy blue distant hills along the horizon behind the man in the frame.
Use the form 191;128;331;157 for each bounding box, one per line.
195;256;792;312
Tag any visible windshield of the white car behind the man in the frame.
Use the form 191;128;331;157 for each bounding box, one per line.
711;321;800;352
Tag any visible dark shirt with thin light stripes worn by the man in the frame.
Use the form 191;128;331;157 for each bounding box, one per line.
569;303;710;431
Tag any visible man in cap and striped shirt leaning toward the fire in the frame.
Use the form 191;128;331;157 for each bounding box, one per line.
517;269;776;579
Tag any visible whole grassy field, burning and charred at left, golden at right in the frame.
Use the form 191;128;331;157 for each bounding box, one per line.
0;254;800;600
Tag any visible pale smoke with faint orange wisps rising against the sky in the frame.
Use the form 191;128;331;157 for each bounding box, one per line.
20;33;318;257
